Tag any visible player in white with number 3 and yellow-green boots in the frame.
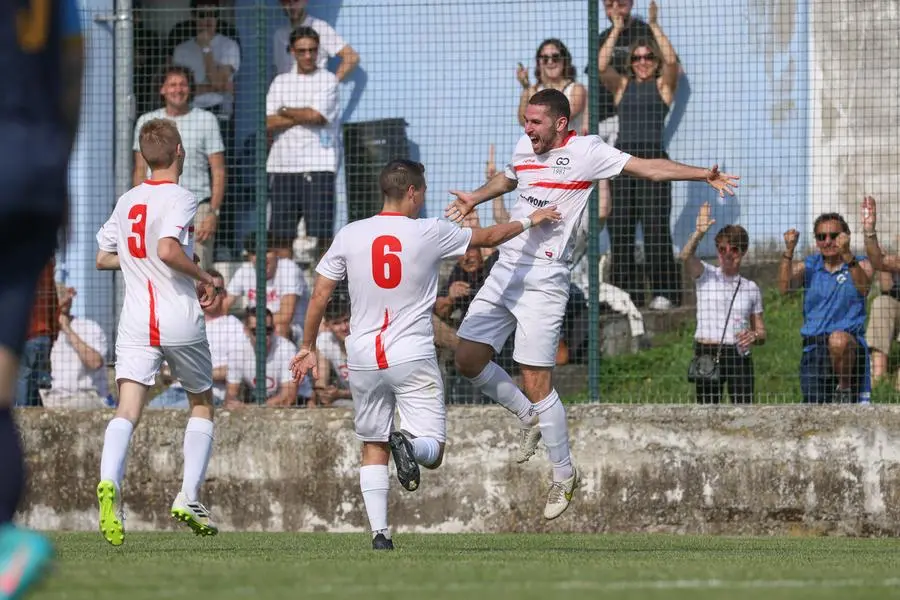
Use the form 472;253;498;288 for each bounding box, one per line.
97;119;221;546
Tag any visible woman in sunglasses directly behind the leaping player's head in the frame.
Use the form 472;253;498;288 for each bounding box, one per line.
516;38;588;135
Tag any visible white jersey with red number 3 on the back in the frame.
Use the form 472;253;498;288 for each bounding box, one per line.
97;181;206;347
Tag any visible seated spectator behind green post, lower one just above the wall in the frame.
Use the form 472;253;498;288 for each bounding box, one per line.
225;306;312;410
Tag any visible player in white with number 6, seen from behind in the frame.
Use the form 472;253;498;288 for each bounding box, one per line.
291;160;560;550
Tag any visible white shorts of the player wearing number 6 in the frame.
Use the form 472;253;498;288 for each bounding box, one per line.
349;358;447;442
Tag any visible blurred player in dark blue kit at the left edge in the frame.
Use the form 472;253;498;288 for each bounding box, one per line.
0;0;84;600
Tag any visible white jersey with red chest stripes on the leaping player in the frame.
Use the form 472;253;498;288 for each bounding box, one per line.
500;131;631;265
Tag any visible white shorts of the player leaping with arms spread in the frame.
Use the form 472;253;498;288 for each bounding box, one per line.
456;261;570;367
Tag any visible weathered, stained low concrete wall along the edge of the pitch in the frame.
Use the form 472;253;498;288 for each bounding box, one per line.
19;405;900;535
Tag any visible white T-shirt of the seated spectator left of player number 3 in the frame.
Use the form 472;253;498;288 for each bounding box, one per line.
50;319;109;398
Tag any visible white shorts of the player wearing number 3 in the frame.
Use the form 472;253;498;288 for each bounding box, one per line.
116;340;212;394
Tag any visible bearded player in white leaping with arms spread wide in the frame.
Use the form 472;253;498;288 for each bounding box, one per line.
447;89;738;519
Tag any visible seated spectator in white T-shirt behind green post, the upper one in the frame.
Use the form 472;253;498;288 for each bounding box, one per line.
225;232;309;340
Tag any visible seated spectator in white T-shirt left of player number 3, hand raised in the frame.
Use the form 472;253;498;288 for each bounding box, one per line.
41;288;114;408
